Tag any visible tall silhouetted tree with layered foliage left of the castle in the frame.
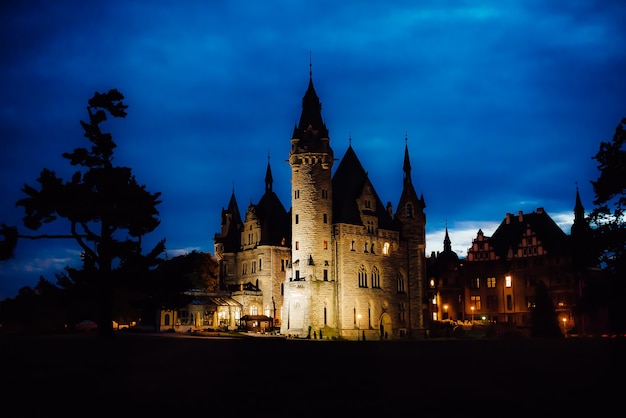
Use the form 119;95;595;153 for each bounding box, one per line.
6;89;165;338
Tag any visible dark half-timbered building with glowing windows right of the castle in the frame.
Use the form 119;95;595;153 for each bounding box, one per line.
429;191;606;334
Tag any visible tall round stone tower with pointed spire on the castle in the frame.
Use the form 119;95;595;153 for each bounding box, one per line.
283;72;335;337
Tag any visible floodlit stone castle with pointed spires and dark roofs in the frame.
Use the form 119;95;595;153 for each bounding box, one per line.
214;74;427;340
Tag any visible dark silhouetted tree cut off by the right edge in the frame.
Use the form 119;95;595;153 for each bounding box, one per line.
589;118;626;334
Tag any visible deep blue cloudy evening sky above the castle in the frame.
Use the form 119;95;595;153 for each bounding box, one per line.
0;0;626;299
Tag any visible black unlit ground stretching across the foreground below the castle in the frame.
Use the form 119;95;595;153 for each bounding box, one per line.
0;333;626;418
